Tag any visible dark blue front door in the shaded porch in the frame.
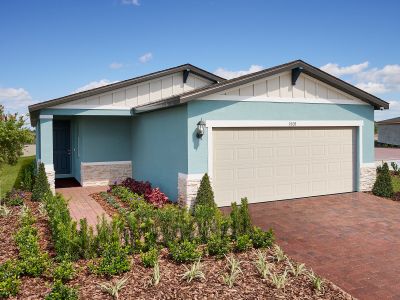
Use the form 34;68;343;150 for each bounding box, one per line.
53;120;71;174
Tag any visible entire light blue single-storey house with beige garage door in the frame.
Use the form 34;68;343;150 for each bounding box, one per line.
29;60;389;206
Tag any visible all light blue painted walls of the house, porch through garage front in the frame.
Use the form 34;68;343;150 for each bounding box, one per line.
37;100;374;200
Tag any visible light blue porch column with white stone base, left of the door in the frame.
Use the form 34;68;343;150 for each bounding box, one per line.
39;115;55;193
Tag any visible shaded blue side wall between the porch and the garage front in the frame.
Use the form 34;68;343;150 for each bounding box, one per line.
131;106;188;201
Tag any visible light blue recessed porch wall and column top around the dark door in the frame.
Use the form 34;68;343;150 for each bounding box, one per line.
36;113;132;181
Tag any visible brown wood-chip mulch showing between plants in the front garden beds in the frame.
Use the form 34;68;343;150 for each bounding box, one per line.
0;192;352;300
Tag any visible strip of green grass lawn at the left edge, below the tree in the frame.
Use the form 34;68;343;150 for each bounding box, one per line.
0;156;35;198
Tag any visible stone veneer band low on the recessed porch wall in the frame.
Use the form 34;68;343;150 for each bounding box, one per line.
81;161;132;186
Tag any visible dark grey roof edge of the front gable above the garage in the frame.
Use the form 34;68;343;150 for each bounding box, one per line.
134;60;389;113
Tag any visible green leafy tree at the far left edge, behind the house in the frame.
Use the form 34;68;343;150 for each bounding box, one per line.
0;105;33;167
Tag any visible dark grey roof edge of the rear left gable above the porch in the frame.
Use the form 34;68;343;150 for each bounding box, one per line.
29;64;225;113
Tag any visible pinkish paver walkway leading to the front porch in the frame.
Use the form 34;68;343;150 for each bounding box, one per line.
56;186;108;228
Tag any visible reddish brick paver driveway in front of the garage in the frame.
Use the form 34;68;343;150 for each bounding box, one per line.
245;193;400;299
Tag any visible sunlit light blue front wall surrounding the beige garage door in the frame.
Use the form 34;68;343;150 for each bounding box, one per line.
187;100;374;174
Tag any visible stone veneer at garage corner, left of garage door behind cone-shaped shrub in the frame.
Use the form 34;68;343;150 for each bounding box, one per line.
178;173;204;208
